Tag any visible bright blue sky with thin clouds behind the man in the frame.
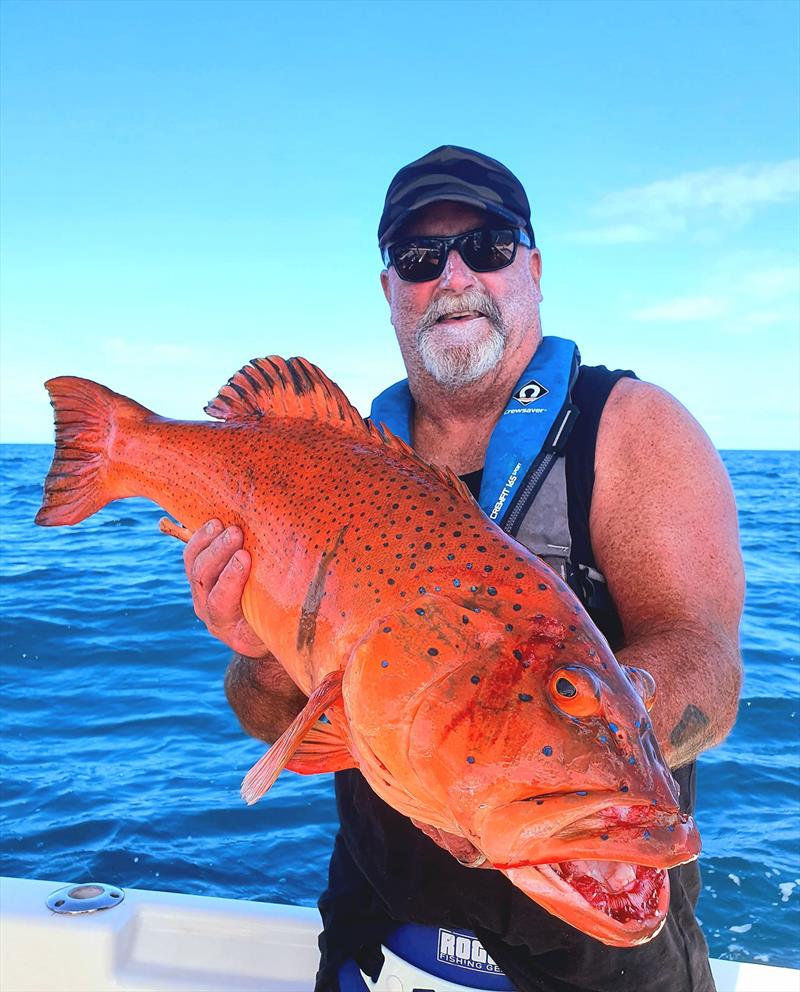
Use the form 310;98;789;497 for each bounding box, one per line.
0;0;800;448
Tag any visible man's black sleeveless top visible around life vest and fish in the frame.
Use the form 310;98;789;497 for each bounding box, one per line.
316;366;714;992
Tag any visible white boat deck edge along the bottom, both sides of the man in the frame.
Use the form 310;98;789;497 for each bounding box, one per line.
0;878;800;992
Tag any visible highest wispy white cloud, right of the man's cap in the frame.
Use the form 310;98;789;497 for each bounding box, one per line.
572;159;800;244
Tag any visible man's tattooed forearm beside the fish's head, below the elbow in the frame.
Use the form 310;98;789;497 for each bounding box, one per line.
617;626;742;768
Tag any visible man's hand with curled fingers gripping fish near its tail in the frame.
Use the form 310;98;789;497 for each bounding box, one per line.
183;520;267;658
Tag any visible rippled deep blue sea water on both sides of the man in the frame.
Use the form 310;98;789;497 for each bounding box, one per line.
0;445;800;967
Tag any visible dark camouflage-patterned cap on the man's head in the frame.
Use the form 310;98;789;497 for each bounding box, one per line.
378;145;536;248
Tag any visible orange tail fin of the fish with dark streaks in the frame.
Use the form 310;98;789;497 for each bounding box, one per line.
36;376;152;527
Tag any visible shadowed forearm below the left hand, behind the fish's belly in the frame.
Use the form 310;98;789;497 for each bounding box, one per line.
225;654;308;744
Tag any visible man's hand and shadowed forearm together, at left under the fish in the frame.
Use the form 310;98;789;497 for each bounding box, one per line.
183;520;307;743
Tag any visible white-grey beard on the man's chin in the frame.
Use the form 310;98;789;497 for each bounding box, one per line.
417;320;505;391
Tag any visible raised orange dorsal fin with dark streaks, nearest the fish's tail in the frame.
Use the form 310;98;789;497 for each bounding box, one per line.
205;355;372;434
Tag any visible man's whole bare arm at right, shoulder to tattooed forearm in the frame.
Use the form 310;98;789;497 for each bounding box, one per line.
590;379;744;768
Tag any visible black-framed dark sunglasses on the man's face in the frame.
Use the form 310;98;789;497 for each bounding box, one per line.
381;227;531;282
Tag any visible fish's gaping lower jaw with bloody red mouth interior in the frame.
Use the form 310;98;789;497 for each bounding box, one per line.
502;860;669;947
